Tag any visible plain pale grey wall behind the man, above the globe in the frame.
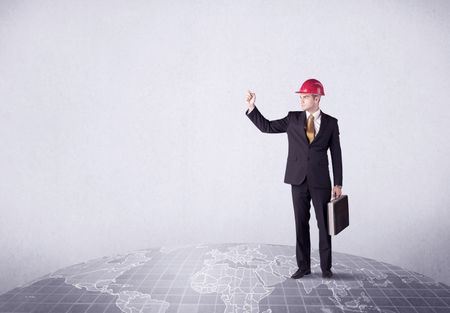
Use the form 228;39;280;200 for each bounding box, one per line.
0;0;450;292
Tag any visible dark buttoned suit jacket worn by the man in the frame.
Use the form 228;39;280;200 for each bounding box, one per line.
245;107;342;189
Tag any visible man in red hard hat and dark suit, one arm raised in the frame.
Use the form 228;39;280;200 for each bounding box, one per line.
246;79;342;279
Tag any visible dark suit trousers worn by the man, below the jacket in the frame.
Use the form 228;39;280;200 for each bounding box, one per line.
291;179;331;271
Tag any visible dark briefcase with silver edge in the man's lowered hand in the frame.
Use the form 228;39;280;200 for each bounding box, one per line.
328;195;349;236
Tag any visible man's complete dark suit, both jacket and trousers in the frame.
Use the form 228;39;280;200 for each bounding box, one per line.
246;107;342;271
